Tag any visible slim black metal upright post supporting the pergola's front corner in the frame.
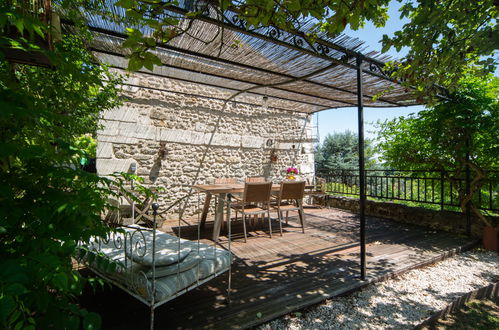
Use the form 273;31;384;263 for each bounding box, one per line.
356;55;366;280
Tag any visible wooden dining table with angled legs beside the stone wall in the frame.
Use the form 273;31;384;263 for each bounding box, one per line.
193;183;281;242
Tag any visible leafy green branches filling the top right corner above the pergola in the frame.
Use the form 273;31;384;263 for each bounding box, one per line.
382;0;499;94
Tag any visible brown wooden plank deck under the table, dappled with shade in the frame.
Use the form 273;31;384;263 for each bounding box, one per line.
81;209;473;329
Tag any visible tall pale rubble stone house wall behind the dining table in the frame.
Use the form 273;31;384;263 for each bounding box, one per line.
97;54;314;219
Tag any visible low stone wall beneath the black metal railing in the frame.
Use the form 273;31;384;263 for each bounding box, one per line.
325;196;498;237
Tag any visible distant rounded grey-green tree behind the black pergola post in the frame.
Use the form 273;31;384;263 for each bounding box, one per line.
315;130;375;171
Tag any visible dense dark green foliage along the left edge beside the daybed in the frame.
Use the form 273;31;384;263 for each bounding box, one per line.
0;2;125;329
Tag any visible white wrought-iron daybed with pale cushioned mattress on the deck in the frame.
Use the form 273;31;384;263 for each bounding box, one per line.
81;197;232;329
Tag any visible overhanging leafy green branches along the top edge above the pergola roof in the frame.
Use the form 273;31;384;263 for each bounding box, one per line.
111;0;499;94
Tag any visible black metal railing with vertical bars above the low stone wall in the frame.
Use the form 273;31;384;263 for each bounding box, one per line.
317;169;499;212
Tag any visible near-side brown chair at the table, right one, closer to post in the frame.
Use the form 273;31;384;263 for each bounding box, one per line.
271;181;305;236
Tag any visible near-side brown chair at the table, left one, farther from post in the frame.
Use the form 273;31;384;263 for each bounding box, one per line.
230;182;272;242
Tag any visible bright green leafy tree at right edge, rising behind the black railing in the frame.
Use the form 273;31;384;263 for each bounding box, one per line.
378;76;499;224
